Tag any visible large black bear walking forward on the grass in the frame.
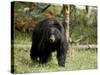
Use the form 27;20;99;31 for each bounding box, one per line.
30;18;66;67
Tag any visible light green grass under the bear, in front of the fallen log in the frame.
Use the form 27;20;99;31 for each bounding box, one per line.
14;48;97;73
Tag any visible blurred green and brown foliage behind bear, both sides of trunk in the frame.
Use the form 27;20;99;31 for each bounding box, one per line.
14;2;97;44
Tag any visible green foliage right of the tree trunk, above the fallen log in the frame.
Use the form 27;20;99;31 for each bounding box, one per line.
70;6;97;44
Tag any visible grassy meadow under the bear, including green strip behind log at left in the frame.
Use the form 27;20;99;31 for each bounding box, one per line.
12;30;97;73
